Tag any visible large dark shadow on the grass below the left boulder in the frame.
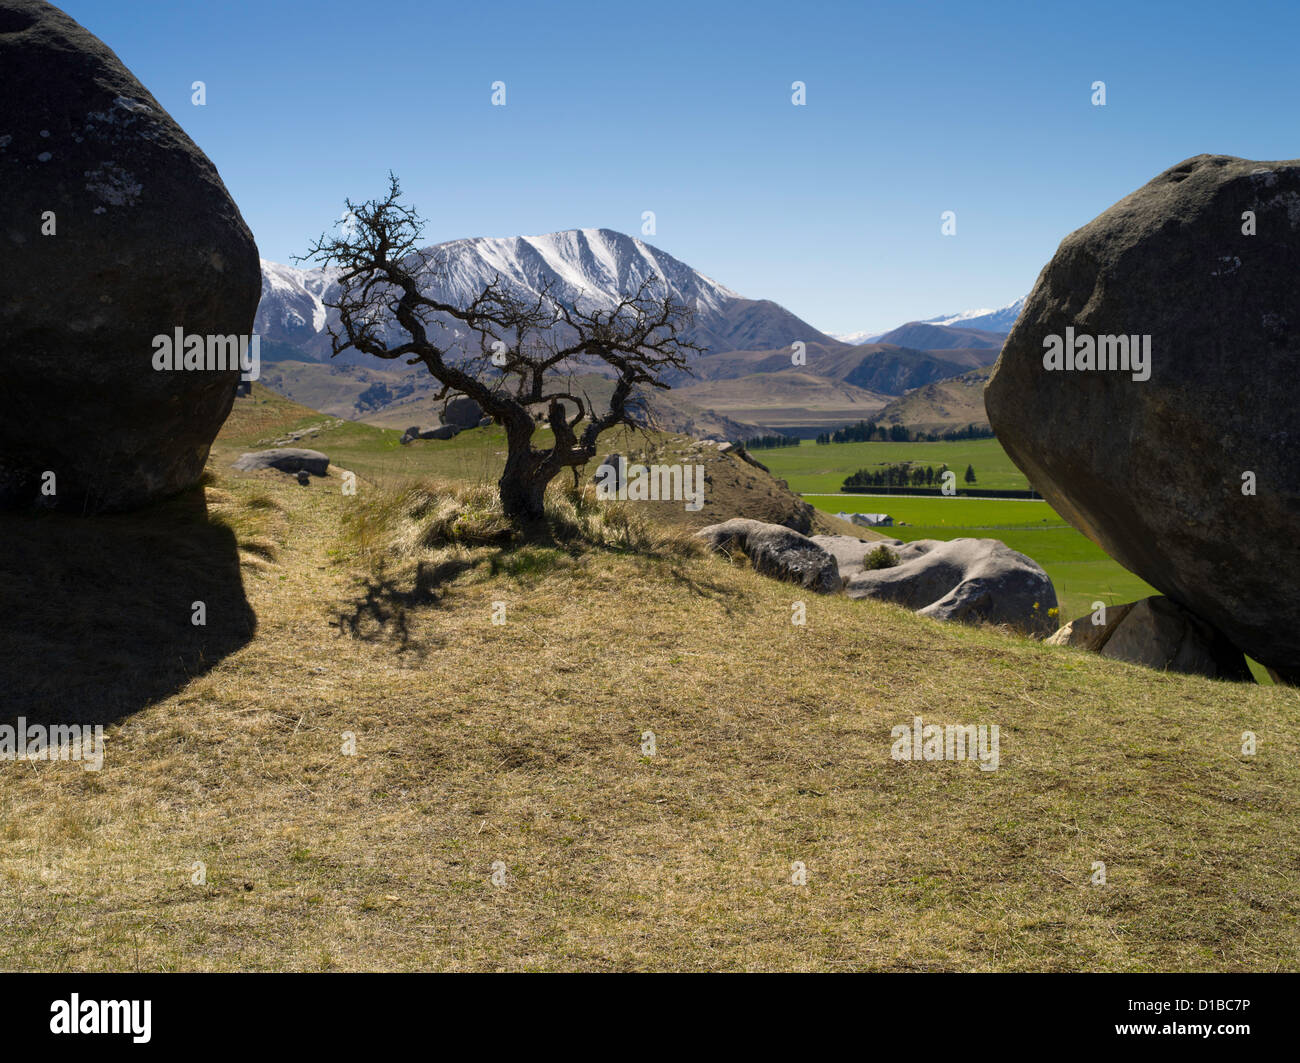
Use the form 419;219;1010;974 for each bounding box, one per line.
0;487;257;725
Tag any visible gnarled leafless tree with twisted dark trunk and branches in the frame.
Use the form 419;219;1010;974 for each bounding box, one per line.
307;174;703;524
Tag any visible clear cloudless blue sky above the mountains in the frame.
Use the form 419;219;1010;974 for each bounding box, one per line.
61;0;1300;333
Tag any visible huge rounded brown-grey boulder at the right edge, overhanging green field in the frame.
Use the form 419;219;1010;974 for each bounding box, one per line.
984;155;1300;680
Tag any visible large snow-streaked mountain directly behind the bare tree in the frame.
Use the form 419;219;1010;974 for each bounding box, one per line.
256;229;831;361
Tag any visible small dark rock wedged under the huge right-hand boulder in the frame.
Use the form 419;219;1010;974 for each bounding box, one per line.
1048;595;1251;681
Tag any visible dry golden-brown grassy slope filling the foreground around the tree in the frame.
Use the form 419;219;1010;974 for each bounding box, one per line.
0;399;1300;971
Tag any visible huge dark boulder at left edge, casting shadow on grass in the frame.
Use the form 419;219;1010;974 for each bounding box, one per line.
0;0;261;512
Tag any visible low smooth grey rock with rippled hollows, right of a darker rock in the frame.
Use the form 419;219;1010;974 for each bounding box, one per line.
832;537;1057;635
